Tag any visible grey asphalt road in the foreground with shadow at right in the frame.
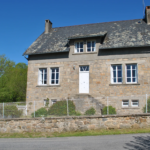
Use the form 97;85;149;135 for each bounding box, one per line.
0;134;150;150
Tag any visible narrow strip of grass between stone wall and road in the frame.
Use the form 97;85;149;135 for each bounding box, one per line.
0;128;150;138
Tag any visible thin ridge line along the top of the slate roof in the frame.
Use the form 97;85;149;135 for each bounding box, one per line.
52;18;143;29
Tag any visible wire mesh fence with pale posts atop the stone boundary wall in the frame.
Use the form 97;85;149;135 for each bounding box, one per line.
0;94;150;119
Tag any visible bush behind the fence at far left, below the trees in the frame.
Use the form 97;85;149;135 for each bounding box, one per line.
4;105;23;118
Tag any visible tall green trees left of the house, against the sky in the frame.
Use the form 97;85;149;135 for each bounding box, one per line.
0;55;27;102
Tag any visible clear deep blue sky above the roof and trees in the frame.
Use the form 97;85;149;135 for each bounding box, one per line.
0;0;150;64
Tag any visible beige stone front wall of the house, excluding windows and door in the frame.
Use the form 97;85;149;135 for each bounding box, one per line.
26;45;150;114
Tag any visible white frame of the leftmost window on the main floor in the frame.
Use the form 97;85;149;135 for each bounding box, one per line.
38;68;47;85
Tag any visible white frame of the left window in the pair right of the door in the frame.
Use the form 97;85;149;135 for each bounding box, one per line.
111;64;123;84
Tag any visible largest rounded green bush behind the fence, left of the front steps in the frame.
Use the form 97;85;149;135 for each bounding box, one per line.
48;100;80;116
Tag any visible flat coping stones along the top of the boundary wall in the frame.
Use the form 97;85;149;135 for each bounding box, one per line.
0;113;150;121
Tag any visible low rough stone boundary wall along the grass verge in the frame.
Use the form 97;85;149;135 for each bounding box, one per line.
0;114;150;133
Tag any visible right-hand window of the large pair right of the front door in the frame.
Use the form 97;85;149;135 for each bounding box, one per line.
126;64;137;83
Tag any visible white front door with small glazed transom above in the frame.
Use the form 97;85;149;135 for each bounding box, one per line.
79;66;89;93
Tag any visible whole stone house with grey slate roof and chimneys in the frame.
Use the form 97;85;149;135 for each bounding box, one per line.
23;6;150;114
